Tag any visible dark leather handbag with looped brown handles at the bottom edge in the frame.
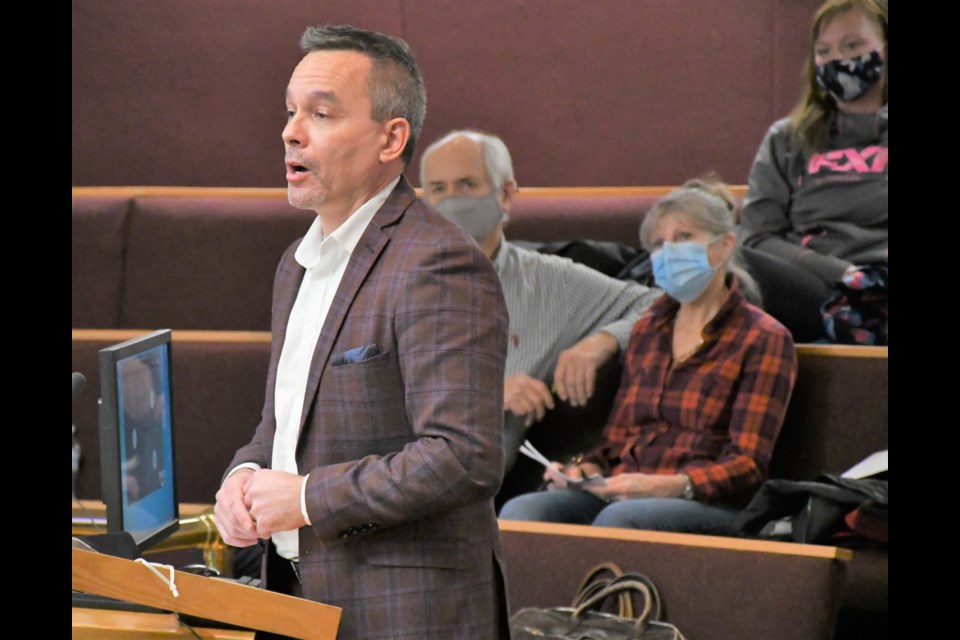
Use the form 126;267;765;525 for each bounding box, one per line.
510;563;685;640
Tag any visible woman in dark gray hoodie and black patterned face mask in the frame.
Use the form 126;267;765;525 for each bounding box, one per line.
741;0;887;340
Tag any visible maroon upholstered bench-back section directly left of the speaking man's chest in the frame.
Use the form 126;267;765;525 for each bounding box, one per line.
120;196;316;331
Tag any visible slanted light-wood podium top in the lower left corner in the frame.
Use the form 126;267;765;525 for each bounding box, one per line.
73;548;340;640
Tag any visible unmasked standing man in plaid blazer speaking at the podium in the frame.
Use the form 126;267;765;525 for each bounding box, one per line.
215;26;508;640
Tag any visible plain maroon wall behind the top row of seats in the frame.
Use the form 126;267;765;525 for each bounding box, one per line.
72;0;820;187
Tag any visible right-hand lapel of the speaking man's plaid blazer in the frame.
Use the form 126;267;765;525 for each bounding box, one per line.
292;176;416;433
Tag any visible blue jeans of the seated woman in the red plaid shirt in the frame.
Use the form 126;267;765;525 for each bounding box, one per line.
499;489;738;535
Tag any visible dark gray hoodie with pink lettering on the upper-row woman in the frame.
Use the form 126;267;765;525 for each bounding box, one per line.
741;105;887;285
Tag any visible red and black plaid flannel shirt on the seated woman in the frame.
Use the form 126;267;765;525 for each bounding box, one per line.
585;277;797;506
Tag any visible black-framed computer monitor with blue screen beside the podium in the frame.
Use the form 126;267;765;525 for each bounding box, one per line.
100;329;180;551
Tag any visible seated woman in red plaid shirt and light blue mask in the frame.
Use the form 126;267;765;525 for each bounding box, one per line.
500;187;797;535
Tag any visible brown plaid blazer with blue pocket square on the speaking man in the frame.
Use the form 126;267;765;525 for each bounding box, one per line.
228;178;508;640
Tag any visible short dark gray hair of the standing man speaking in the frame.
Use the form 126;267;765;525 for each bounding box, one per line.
300;25;427;164
